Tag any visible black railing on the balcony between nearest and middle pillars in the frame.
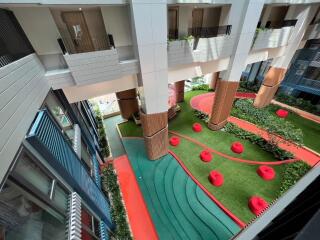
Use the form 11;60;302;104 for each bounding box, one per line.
188;25;232;38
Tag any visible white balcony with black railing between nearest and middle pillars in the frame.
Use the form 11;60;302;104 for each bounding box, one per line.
168;25;234;67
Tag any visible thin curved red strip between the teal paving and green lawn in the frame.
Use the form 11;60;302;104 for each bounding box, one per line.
169;150;246;228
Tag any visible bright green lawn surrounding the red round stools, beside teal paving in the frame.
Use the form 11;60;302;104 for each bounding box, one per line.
120;91;290;223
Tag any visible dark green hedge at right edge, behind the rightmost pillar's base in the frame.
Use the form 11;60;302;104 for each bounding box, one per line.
276;93;320;115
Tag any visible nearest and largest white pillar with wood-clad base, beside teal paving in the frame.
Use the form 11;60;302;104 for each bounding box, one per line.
130;0;168;160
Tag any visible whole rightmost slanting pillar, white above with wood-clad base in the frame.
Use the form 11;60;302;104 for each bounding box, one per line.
254;5;317;108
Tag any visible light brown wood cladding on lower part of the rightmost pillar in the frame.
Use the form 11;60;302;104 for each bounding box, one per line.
253;67;286;108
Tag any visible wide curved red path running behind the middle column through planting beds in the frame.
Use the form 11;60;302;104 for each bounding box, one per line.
190;93;320;166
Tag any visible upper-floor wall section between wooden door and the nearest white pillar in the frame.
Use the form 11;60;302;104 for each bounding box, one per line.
101;5;132;47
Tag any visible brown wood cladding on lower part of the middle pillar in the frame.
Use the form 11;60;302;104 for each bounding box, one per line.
208;80;239;130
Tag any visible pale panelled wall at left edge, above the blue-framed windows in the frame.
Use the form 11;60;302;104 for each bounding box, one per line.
0;54;49;182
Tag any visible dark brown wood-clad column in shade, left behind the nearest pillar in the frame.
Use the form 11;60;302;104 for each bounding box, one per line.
116;88;139;119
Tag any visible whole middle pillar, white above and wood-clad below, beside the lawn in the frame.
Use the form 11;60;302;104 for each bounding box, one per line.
208;0;264;130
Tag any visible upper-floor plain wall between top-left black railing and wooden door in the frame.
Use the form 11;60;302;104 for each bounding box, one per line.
10;7;61;55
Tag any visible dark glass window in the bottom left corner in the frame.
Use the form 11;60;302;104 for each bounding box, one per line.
0;182;67;240
